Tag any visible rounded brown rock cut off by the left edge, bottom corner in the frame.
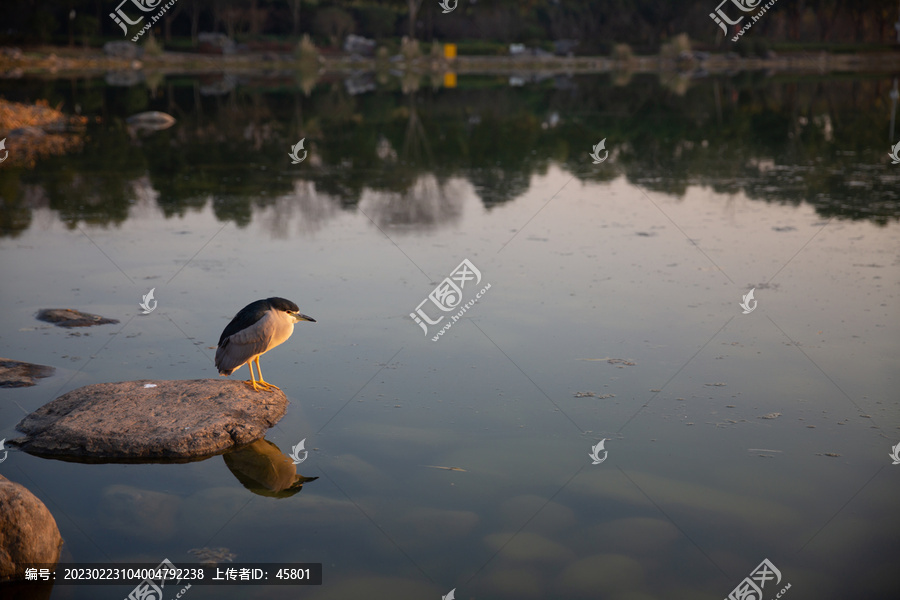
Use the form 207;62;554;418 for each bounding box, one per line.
0;475;62;582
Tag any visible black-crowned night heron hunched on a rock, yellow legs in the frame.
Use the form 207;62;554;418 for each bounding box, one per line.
216;298;316;392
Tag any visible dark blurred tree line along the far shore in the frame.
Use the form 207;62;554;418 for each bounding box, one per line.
0;0;898;54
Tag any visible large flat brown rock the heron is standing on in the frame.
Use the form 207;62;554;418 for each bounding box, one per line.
8;379;288;462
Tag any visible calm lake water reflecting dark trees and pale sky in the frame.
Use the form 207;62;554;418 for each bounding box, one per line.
0;73;900;600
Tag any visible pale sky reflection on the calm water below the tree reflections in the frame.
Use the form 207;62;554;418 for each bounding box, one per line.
0;72;900;600
